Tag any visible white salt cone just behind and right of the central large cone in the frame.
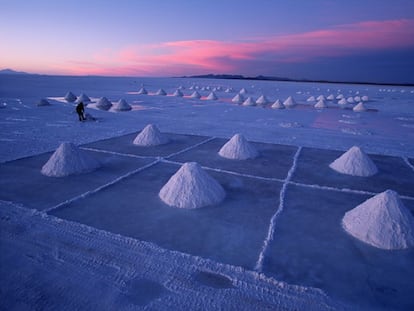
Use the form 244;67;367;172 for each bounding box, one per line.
218;134;259;160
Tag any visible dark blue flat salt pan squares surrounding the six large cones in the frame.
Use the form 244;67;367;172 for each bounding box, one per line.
0;130;414;310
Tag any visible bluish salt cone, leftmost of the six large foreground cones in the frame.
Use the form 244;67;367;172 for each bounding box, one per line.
41;142;100;177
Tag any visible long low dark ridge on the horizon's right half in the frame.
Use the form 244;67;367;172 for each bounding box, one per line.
178;73;414;86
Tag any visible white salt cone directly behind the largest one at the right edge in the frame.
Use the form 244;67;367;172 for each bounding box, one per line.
329;146;378;177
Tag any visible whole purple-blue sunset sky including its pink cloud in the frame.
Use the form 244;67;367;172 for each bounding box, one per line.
0;0;414;83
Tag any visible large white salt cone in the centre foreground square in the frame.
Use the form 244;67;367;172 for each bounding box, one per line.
159;162;226;209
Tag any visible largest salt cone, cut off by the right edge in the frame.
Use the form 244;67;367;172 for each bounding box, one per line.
342;190;414;250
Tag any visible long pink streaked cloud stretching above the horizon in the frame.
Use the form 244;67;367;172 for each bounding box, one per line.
59;19;414;76
